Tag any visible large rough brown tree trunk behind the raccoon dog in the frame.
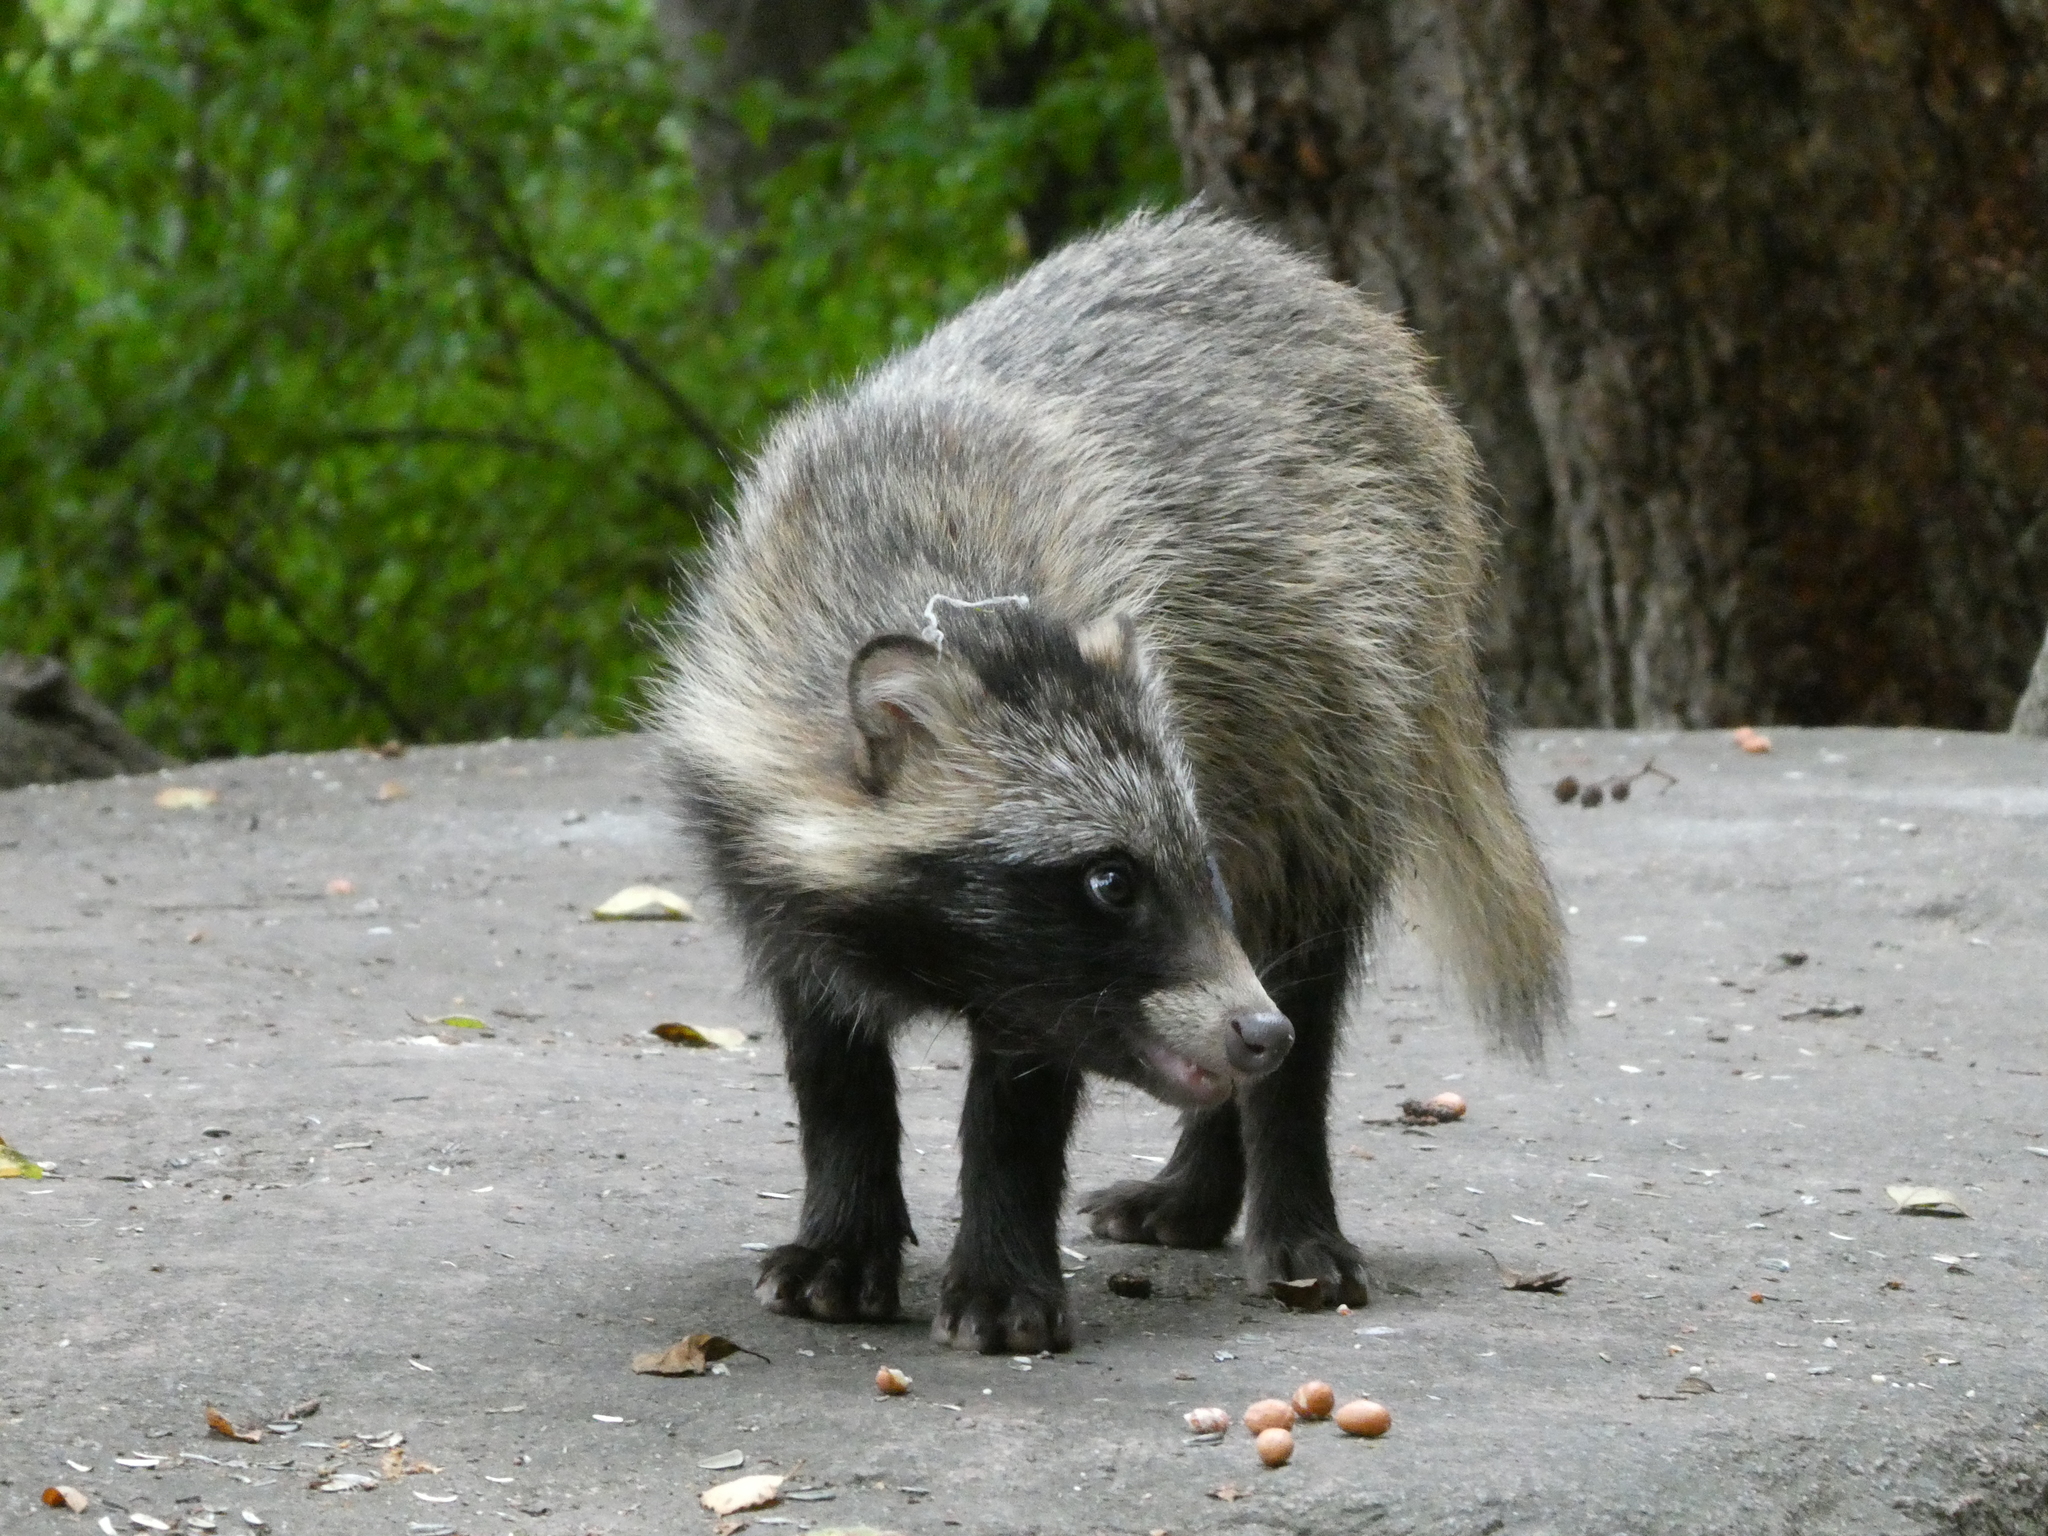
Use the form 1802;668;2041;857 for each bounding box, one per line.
1139;0;2048;729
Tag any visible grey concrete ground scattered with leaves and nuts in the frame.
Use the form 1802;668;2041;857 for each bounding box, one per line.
0;731;2048;1536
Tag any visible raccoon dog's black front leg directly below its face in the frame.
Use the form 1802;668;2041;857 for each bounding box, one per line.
932;1044;1081;1354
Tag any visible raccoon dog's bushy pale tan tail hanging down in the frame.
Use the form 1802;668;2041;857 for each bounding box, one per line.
1409;719;1567;1061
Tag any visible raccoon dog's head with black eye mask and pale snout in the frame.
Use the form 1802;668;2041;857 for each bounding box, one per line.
815;604;1294;1106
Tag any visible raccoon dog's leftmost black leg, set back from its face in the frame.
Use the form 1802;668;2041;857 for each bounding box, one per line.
754;987;918;1323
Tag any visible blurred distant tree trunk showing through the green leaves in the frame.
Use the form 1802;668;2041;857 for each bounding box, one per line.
653;0;868;233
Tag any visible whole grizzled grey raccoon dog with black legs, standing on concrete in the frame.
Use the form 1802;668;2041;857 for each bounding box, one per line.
657;211;1563;1354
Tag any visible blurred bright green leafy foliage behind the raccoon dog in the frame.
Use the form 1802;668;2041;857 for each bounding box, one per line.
0;0;1178;758
